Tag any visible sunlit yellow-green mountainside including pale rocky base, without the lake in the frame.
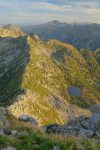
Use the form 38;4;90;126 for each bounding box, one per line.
10;36;100;125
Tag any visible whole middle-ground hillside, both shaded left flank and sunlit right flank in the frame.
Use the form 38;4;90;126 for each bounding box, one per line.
0;25;100;125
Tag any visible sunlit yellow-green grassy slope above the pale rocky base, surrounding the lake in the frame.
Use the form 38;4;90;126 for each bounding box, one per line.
22;37;100;106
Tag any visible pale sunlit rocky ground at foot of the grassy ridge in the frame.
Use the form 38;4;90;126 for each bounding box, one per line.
8;90;91;126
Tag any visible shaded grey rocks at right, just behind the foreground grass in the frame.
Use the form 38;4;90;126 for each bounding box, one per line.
45;107;100;140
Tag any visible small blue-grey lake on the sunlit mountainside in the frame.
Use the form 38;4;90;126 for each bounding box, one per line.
67;86;81;97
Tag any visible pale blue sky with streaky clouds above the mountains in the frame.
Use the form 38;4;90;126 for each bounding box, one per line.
0;0;100;25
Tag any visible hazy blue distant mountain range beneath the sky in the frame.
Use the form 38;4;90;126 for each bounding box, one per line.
22;21;100;50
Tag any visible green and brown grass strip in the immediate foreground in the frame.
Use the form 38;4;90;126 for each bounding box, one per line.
0;115;100;150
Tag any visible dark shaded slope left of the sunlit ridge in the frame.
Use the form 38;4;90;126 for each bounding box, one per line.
0;37;29;105
